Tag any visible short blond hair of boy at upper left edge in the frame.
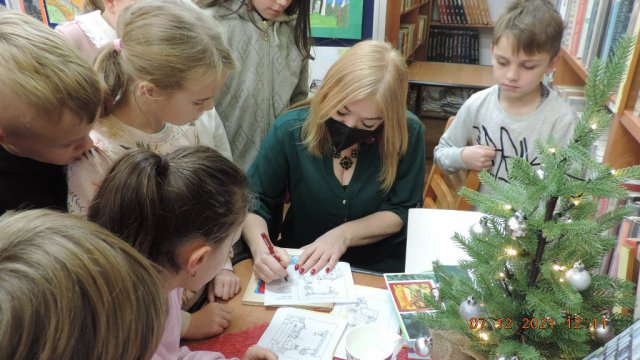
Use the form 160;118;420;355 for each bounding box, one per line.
0;10;103;126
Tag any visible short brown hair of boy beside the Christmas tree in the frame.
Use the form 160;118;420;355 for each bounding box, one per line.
492;0;564;59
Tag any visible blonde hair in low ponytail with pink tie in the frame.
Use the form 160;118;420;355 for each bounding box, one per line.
95;0;236;116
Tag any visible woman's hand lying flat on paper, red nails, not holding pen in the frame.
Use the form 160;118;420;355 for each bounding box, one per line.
296;227;349;275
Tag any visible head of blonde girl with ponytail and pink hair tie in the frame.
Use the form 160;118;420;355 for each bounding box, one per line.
96;0;235;125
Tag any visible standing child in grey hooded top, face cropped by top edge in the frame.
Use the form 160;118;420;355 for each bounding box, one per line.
196;0;311;170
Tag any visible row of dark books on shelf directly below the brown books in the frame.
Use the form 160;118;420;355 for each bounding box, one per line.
427;27;480;64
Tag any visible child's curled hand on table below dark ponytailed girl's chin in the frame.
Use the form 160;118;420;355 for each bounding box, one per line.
182;302;231;339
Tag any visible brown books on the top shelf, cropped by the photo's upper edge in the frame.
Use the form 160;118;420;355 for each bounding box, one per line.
438;0;491;25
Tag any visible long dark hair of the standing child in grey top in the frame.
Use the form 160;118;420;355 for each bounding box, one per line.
195;0;311;59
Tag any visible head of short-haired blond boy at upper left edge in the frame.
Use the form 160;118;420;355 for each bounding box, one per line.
0;11;103;164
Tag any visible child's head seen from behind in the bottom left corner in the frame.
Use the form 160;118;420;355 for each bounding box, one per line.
0;210;166;359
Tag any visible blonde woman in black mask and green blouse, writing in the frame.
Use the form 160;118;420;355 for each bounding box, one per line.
243;41;425;281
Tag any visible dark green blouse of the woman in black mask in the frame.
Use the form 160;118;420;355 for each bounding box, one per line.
247;107;425;267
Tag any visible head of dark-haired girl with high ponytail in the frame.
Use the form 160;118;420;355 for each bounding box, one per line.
89;146;249;290
